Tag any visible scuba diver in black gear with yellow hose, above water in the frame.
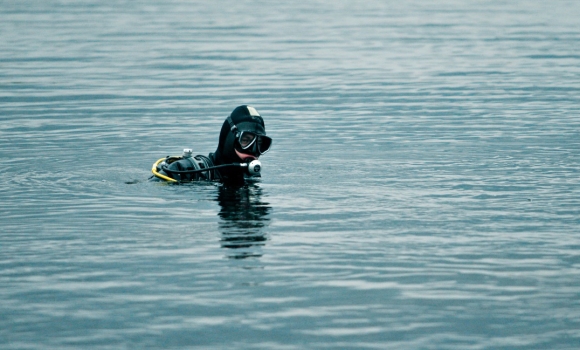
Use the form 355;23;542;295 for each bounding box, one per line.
151;105;272;183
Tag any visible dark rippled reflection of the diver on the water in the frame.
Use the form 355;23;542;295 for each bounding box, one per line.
216;183;271;259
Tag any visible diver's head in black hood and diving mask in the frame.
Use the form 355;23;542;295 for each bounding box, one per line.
215;105;272;164
